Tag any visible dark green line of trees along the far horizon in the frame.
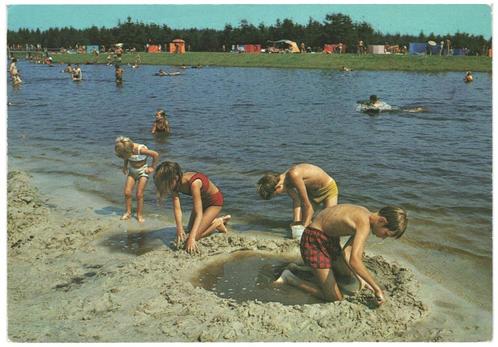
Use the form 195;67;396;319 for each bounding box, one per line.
7;13;492;55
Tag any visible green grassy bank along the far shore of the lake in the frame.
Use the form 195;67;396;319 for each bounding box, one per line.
18;52;492;72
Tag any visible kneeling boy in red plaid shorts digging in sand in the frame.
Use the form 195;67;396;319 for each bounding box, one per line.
274;204;408;305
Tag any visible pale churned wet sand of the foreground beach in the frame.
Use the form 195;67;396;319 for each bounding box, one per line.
7;171;430;342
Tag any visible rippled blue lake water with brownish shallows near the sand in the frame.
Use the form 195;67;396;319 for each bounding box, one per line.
7;62;492;340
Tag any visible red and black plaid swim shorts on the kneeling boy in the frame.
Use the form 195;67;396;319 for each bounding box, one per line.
301;227;342;269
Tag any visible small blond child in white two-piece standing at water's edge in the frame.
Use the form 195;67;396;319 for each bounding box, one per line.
114;136;159;223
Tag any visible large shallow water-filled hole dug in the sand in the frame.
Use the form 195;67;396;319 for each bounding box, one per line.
193;251;322;305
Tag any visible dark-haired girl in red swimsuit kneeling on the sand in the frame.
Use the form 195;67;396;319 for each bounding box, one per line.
154;161;231;253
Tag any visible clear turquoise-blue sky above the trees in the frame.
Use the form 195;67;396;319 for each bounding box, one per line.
7;3;492;38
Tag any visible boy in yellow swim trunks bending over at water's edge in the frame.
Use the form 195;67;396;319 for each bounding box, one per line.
256;163;339;227
